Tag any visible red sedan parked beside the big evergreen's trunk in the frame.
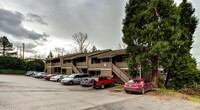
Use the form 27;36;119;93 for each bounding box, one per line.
124;78;153;94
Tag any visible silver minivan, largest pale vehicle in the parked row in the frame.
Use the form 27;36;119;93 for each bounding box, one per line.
61;73;89;85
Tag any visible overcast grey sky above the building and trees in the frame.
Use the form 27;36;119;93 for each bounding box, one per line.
0;0;200;62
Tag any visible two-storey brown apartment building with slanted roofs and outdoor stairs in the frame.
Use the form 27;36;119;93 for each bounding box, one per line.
46;49;131;82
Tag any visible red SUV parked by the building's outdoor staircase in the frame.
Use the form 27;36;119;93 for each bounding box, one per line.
91;76;116;89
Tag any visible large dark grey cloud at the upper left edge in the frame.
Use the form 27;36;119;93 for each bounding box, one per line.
0;9;48;41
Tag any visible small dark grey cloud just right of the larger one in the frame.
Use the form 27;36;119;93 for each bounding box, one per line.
27;13;48;25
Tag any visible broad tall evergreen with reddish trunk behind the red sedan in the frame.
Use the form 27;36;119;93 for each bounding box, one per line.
122;0;179;86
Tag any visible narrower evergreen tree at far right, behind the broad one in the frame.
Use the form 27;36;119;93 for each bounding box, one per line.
165;0;199;88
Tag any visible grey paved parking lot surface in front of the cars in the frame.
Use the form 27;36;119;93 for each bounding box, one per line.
0;75;200;110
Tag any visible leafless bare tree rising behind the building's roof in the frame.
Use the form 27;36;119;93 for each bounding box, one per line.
72;32;90;53
